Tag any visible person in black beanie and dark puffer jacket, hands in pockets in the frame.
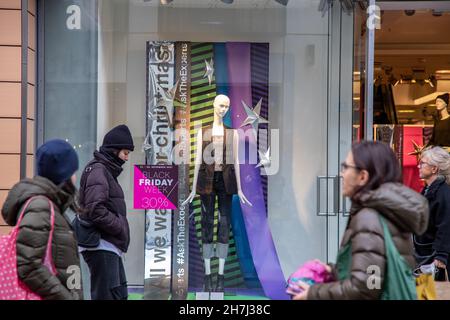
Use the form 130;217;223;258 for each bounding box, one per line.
79;125;134;300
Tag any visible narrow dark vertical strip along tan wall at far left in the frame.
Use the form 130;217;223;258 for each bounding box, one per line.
20;0;28;179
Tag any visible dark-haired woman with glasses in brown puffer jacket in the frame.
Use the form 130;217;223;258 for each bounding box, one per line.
294;142;428;300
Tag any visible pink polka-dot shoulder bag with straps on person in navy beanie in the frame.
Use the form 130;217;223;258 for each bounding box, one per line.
0;196;57;300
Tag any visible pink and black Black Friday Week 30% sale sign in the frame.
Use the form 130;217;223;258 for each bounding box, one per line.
134;165;178;210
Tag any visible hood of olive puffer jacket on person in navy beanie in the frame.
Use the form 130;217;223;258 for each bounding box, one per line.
2;176;72;226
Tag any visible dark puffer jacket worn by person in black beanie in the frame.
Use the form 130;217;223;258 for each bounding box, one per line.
80;151;130;252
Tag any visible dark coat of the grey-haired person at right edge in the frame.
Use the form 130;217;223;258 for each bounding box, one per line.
414;177;450;264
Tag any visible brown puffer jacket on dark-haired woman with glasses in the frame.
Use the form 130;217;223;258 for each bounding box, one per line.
307;183;429;300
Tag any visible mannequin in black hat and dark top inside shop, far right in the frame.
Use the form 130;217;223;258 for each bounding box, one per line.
429;93;450;151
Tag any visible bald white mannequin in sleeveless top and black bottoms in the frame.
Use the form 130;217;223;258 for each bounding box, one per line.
183;95;252;292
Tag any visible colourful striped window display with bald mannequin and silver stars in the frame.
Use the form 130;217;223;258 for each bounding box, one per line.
144;42;285;298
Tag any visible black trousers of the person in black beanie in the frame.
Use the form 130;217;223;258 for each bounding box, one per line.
82;250;128;300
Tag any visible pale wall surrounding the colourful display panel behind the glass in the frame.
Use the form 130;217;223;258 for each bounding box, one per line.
98;0;354;285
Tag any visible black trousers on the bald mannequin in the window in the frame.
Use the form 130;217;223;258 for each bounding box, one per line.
200;171;233;244
